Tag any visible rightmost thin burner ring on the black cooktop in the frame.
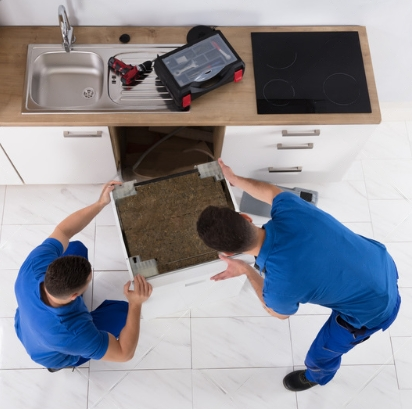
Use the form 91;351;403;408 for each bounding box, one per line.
323;72;361;106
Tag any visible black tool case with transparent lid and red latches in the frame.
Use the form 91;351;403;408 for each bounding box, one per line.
154;30;245;110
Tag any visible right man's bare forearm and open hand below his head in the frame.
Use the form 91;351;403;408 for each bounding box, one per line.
211;255;289;320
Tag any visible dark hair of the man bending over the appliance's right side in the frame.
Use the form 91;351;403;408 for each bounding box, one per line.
197;206;257;253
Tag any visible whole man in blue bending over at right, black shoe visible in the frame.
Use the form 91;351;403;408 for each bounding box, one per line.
197;159;400;391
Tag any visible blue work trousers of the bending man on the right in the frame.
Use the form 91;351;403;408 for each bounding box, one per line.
305;294;401;385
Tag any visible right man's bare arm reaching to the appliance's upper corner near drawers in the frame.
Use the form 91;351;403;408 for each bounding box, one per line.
218;158;282;205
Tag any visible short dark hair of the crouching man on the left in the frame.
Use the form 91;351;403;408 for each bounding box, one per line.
44;256;92;298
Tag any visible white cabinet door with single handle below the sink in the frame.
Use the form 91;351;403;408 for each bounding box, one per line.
0;126;117;184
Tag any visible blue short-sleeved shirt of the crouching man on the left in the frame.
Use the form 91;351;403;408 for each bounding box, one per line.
15;238;109;368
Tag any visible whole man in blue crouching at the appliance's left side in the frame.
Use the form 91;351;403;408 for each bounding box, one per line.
15;181;152;372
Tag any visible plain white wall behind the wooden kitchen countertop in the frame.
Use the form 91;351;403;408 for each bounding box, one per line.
0;0;412;111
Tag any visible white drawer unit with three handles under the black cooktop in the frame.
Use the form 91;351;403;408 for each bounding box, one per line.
221;125;377;183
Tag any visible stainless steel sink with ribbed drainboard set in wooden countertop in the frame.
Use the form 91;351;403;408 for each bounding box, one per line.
22;44;182;114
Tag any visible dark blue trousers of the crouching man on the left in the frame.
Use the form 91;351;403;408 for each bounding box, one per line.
62;241;129;366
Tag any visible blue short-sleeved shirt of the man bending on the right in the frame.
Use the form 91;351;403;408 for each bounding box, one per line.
256;192;398;328
